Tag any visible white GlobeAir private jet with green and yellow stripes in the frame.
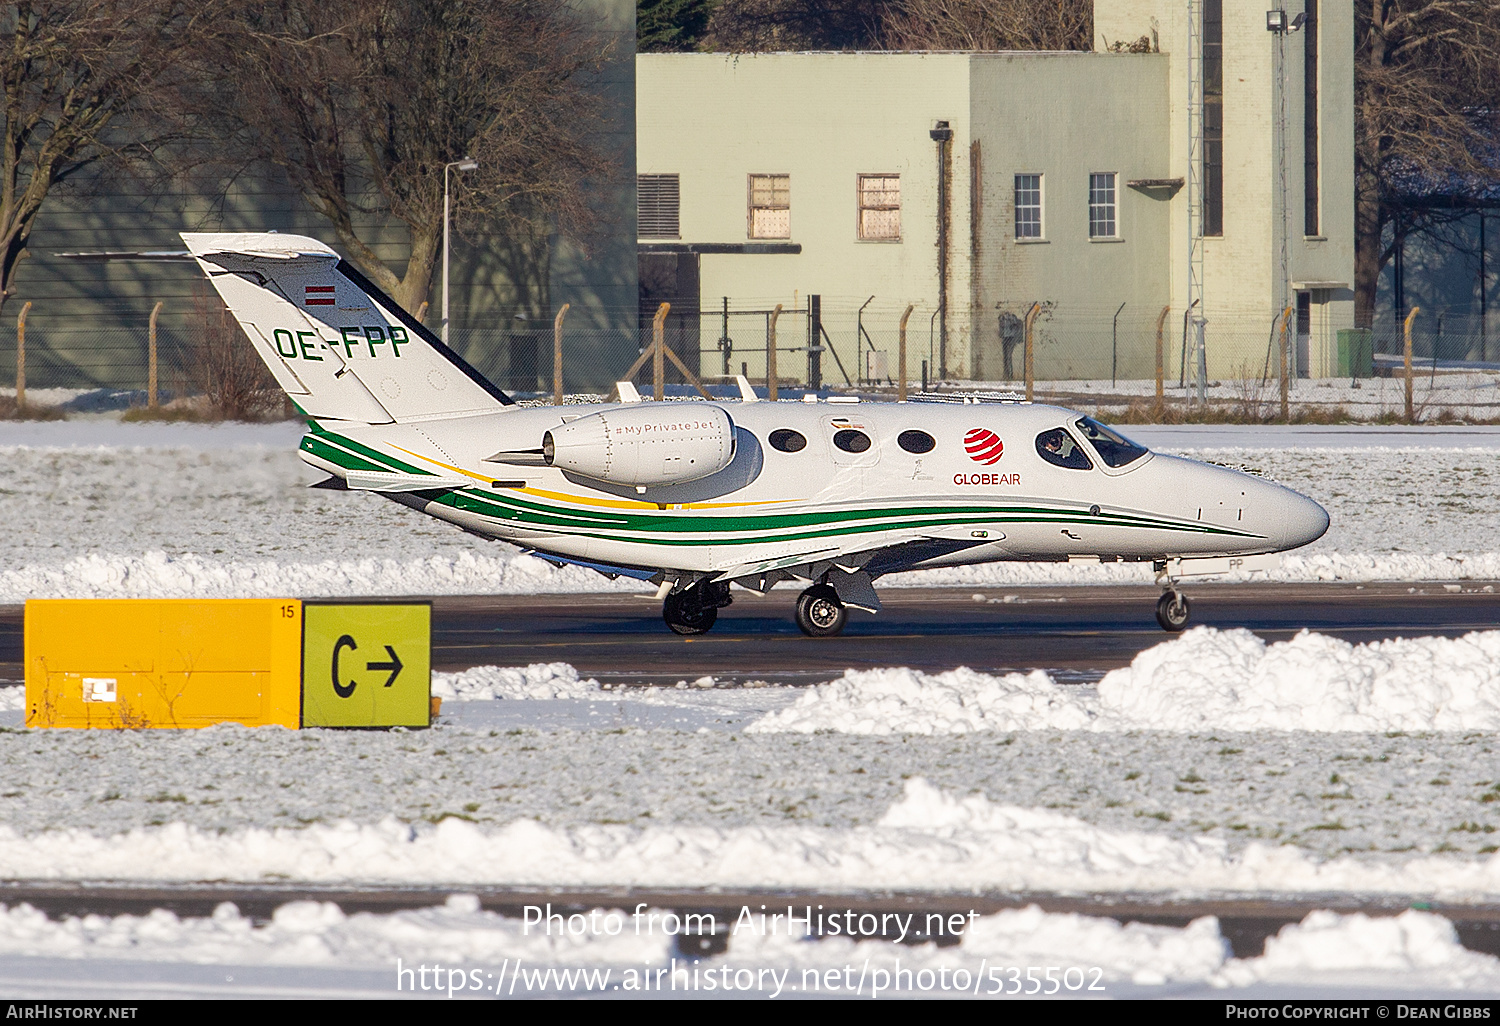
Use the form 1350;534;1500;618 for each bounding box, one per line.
183;233;1328;638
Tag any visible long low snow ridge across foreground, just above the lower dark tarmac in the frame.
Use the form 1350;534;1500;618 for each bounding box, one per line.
0;779;1500;900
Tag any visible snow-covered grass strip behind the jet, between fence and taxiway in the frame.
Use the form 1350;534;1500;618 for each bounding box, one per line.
0;419;1500;602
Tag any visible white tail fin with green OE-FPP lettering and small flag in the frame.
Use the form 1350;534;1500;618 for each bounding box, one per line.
182;233;515;425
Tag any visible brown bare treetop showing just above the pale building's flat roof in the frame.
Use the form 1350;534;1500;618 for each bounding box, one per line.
882;0;1094;50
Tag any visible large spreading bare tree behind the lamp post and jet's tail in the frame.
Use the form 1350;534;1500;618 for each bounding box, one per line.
204;0;614;311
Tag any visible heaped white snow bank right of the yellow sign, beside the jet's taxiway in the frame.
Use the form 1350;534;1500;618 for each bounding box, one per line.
747;627;1500;734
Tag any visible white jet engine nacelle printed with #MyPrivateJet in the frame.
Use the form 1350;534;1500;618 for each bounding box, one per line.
542;402;735;488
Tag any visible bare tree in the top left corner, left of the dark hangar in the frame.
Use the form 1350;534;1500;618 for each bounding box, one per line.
0;0;222;316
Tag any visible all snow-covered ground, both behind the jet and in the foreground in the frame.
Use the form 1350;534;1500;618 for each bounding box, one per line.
0;420;1500;996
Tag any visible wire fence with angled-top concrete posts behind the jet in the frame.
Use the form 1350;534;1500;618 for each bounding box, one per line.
0;297;1500;420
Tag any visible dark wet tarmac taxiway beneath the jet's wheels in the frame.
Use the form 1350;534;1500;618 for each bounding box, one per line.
0;581;1500;684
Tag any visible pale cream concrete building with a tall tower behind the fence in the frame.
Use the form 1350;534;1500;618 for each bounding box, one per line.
636;0;1353;383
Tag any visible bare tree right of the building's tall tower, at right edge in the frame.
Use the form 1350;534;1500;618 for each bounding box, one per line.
1355;0;1500;327
